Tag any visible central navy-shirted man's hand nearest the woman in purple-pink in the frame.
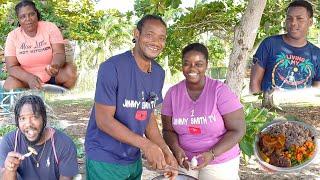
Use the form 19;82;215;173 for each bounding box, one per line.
162;146;179;180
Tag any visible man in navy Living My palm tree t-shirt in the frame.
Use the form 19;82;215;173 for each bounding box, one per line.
250;1;320;94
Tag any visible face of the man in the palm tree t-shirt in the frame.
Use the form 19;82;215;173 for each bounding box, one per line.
285;6;312;40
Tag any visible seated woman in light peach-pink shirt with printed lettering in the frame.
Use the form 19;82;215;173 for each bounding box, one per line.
4;1;77;90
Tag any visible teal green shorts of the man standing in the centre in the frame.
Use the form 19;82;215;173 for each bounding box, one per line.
86;159;142;180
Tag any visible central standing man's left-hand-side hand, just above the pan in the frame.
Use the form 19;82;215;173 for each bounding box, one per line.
141;141;167;170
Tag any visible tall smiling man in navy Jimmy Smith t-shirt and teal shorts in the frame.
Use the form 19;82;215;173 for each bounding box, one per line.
85;15;177;180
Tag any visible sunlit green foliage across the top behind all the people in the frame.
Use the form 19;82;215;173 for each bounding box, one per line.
0;0;320;74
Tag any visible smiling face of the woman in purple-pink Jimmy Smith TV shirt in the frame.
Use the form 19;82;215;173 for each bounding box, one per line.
182;50;208;85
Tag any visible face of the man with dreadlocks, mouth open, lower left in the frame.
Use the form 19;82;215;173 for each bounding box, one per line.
18;104;44;144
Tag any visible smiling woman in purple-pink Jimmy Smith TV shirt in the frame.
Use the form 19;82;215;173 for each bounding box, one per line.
161;43;245;180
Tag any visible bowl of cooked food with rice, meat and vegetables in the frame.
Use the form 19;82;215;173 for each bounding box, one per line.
255;121;316;171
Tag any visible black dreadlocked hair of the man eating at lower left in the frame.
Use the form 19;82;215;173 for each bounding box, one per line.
14;95;47;128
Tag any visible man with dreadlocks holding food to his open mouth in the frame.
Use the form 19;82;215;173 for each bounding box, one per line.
0;95;78;180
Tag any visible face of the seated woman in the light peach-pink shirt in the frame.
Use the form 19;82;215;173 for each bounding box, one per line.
17;6;39;33
